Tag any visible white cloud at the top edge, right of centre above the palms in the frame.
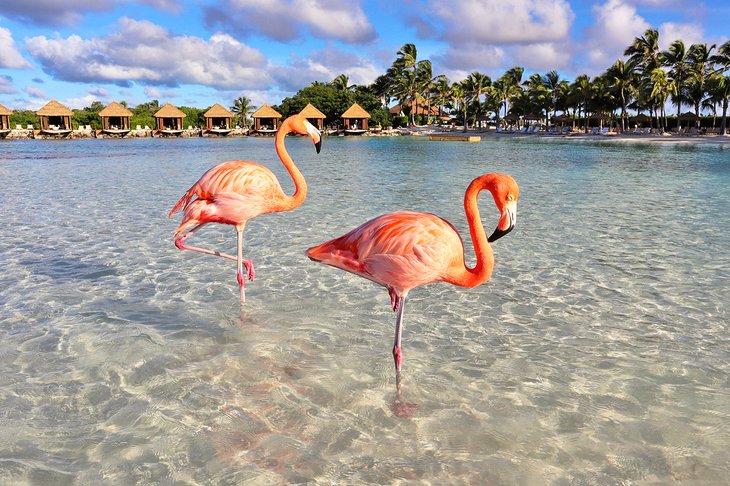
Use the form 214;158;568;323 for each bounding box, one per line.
421;0;575;44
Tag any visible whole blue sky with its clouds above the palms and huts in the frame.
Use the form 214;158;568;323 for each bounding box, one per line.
0;0;730;109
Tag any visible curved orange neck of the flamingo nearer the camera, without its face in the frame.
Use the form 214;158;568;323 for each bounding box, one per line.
452;175;494;287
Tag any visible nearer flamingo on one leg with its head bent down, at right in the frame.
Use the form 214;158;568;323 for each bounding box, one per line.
307;174;519;384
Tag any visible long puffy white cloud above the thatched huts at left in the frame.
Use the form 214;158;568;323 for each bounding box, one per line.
26;17;270;89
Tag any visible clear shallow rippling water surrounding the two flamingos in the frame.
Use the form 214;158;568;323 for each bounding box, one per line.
0;138;730;485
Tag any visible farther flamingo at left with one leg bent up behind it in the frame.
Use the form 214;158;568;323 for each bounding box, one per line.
168;115;322;304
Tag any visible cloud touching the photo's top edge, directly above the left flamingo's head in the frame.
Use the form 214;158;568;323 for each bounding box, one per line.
205;0;376;44
